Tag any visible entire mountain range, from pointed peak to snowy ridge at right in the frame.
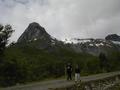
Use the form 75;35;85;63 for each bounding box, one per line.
17;22;120;55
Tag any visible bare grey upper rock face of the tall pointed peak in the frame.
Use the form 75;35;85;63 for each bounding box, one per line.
18;22;51;43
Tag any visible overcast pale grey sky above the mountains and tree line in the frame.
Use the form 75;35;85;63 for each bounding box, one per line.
0;0;120;41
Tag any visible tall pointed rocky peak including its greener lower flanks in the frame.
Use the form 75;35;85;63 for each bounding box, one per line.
17;22;57;49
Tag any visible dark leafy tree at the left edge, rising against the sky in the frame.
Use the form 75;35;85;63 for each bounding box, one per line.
0;24;14;85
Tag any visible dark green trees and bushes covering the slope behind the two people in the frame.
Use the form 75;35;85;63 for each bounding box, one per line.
0;46;120;86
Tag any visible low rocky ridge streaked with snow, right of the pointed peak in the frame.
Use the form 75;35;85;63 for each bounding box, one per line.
65;38;120;55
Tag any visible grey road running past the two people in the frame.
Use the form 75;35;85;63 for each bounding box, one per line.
0;72;120;90
